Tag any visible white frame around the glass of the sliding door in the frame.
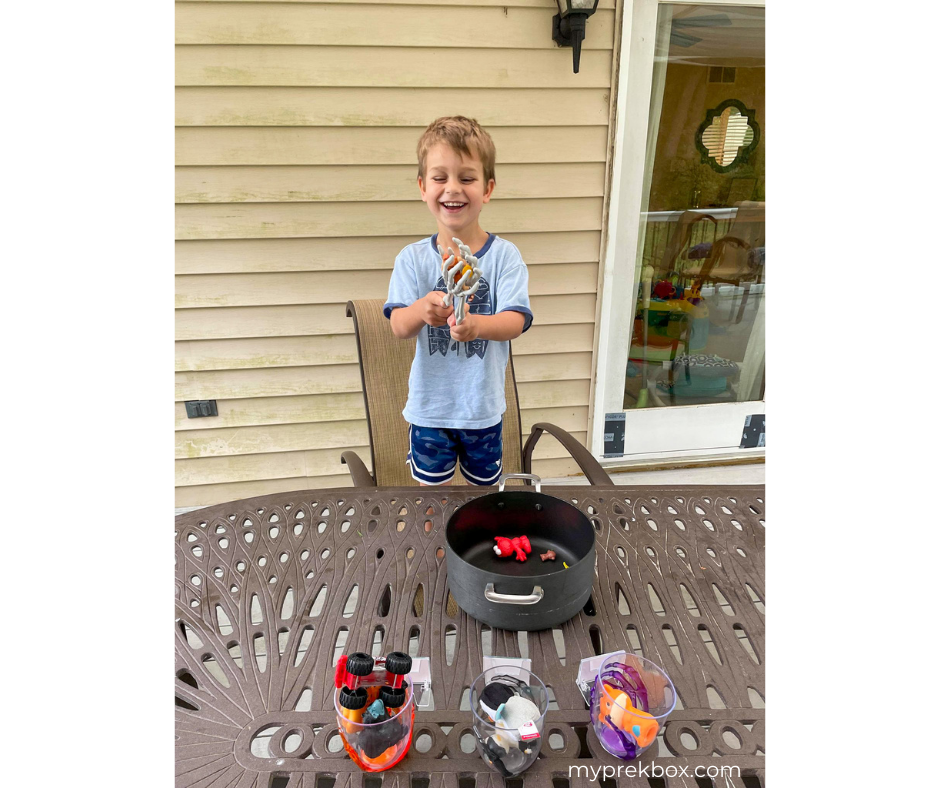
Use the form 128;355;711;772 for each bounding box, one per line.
588;0;767;466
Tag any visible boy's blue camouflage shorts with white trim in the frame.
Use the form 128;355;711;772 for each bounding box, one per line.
407;421;503;486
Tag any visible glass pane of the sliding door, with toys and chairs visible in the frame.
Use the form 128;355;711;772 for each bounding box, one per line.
623;3;767;409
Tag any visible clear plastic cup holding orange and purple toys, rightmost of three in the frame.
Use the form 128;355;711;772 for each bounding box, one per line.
591;651;676;761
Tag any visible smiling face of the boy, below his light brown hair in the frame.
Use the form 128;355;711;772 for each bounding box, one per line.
418;143;496;249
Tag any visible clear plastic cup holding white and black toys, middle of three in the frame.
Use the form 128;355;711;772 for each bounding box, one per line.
470;665;548;777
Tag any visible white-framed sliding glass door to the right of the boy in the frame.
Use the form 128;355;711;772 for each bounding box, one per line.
592;0;767;460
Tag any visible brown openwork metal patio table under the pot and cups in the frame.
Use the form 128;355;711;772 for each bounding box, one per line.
174;485;766;788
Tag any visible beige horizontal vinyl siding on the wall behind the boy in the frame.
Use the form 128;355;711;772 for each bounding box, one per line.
174;0;616;507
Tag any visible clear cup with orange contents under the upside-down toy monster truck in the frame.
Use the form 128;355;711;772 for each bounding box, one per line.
333;685;415;772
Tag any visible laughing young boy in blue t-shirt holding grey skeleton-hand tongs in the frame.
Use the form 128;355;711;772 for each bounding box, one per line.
384;116;532;486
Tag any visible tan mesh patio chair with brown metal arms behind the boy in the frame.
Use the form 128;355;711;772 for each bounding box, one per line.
342;299;612;487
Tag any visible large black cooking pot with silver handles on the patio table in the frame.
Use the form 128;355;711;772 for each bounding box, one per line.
444;473;594;630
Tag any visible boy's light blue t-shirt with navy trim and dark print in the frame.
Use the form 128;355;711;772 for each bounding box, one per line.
384;233;532;430
